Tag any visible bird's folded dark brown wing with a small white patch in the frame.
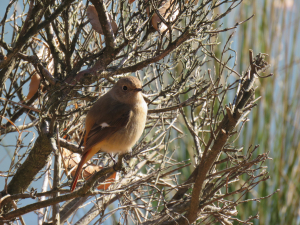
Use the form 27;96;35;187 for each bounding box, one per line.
84;104;132;152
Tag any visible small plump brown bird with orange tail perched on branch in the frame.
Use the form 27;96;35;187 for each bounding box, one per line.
71;76;148;192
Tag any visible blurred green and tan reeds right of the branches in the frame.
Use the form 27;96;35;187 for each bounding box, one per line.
224;0;300;224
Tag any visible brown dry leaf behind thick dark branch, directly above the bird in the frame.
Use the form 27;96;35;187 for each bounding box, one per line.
86;5;118;34
